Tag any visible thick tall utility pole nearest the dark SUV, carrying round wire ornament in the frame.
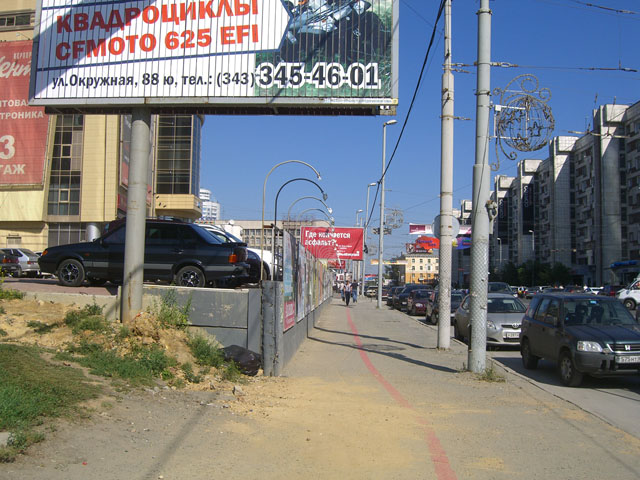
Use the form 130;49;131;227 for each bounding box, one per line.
468;0;491;373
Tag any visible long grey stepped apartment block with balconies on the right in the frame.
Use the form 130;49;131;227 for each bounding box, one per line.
491;102;640;285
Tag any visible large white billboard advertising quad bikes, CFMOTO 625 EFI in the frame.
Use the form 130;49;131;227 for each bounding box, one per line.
31;0;399;115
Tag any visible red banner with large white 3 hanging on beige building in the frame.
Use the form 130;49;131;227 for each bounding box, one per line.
0;41;49;185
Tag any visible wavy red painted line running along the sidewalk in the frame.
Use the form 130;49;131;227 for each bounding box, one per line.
346;310;458;480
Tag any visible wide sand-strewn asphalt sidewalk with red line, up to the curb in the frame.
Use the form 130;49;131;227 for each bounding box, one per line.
0;301;640;480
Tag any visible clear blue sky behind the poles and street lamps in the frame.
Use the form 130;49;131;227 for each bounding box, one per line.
200;0;640;258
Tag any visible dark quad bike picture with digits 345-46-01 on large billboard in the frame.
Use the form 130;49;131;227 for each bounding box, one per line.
256;0;393;97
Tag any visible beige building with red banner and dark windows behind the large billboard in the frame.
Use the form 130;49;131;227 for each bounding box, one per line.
0;0;203;251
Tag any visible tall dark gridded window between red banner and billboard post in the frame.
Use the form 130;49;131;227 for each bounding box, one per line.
47;115;84;215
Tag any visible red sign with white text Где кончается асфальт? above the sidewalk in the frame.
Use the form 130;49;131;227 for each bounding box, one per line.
301;227;363;260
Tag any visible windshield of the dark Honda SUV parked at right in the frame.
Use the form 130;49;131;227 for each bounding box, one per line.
564;299;637;325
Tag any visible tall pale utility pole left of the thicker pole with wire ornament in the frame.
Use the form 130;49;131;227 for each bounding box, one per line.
438;0;453;349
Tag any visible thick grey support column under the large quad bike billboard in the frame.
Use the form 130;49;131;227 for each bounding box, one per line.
121;108;151;324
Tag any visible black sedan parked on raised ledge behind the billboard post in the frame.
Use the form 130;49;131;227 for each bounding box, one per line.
38;220;249;287
